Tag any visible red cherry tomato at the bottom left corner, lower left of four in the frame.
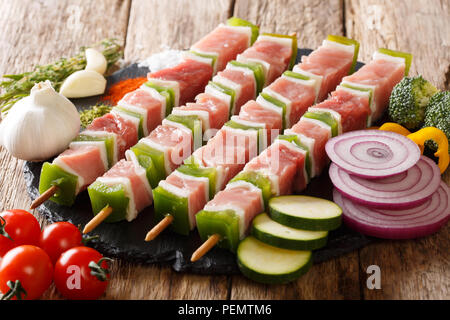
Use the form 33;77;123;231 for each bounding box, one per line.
0;245;53;300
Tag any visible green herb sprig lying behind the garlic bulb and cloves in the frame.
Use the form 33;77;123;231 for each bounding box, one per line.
0;39;123;116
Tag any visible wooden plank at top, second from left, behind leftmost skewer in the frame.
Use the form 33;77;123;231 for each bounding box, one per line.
125;0;232;61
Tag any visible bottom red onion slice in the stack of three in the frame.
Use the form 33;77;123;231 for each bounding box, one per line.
333;181;450;239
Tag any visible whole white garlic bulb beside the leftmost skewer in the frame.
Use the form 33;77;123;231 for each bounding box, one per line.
0;80;80;161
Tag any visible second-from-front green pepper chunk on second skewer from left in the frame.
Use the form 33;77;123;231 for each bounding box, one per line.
130;142;166;188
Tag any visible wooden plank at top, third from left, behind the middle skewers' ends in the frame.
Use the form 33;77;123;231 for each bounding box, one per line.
234;0;344;49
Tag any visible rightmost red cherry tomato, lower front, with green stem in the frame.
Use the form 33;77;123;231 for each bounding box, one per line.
54;247;111;300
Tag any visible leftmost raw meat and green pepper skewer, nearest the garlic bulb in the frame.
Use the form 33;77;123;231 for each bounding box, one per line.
32;18;258;208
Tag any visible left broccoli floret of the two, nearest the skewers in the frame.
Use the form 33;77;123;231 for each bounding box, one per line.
389;75;438;130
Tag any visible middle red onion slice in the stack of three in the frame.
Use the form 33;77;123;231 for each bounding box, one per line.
329;156;441;209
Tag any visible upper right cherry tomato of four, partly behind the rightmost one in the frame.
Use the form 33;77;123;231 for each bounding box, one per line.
39;222;83;263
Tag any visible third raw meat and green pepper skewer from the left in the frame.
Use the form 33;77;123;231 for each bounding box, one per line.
146;36;359;240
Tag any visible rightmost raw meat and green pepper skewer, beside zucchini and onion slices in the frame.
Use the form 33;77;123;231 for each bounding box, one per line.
192;49;411;261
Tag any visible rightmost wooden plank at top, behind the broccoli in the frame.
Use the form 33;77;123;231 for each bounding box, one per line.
345;0;450;89
